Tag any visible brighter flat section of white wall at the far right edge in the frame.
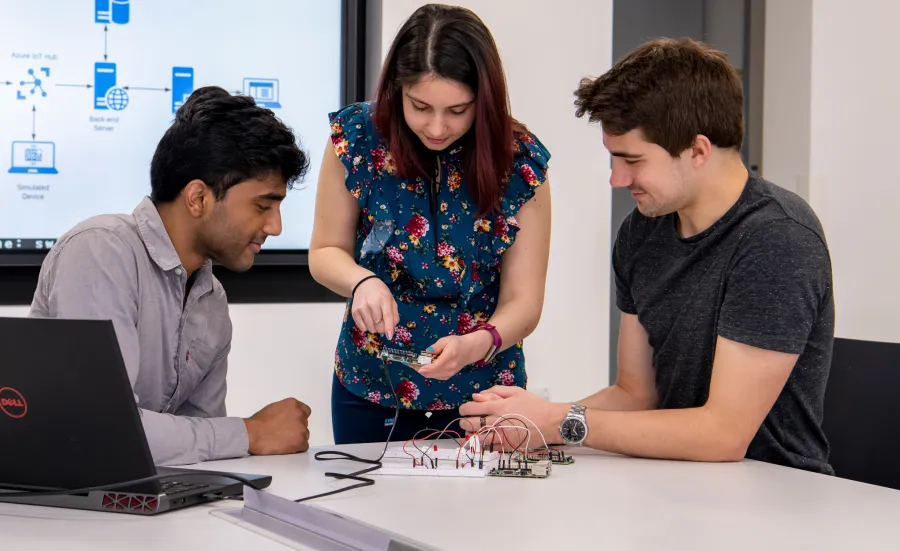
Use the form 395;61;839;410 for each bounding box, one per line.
809;0;900;342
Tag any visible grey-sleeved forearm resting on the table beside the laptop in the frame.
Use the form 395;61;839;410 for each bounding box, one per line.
140;409;249;465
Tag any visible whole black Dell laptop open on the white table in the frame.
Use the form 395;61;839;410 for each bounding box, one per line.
0;318;272;515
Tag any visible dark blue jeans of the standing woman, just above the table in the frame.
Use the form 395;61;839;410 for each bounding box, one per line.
331;375;466;444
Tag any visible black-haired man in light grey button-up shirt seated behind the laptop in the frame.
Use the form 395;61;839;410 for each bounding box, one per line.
31;87;309;464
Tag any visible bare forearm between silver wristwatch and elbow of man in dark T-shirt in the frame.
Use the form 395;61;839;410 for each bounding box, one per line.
585;407;749;461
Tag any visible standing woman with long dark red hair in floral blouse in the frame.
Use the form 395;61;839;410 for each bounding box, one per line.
309;5;550;444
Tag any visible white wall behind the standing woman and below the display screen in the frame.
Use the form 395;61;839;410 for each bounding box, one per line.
0;0;612;445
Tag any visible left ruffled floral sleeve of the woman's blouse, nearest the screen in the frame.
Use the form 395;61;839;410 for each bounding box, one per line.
328;103;375;207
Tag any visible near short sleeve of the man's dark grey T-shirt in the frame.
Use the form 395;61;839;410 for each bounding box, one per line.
718;220;832;354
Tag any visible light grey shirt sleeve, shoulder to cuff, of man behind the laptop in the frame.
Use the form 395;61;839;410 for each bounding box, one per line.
42;229;248;465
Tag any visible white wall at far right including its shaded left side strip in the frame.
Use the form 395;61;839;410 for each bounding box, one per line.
763;0;900;342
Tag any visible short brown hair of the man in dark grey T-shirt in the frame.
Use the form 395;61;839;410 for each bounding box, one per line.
575;38;744;157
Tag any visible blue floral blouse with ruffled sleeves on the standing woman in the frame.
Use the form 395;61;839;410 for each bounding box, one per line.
329;102;550;410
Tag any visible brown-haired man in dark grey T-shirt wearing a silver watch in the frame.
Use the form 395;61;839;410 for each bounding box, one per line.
460;39;834;474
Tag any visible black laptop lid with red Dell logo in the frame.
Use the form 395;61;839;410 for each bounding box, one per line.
0;318;156;489
